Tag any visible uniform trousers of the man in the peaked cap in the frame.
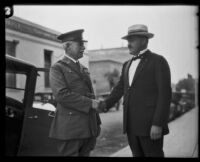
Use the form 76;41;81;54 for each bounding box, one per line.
57;137;96;156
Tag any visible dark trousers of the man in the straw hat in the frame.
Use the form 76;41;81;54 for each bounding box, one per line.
127;134;164;157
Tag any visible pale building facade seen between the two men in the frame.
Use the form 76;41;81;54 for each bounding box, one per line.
87;47;131;96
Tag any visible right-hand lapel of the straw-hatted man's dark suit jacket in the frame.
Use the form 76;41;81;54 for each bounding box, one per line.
131;50;149;86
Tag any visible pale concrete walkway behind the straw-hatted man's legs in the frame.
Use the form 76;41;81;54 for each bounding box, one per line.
111;108;199;158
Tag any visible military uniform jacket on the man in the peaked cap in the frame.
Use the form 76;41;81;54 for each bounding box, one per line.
49;57;101;140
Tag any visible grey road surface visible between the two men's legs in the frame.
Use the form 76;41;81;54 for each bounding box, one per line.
90;109;128;157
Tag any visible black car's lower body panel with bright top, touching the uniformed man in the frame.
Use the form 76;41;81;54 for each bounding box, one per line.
20;103;58;156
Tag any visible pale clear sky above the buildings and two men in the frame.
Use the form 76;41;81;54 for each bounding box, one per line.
14;5;199;83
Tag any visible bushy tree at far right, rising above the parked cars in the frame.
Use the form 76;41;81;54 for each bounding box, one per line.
176;74;195;93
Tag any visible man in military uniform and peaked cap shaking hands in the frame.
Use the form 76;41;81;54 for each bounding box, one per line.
49;29;101;156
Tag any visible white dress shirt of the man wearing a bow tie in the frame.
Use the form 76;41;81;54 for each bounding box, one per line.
128;49;148;86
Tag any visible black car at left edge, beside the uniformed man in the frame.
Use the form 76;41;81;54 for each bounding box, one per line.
5;55;58;156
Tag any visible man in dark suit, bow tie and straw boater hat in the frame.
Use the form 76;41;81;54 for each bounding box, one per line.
99;24;171;157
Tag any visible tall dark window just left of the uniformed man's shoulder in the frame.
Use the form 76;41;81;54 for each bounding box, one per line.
44;50;52;88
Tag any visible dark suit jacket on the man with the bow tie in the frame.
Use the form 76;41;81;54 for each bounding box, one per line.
106;50;171;136
